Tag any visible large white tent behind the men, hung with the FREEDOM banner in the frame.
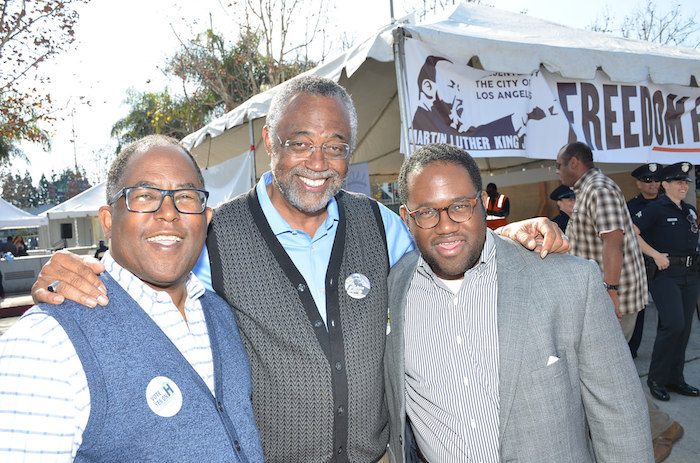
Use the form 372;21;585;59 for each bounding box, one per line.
183;4;700;185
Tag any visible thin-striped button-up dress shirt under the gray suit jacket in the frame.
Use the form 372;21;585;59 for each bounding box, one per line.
404;231;499;463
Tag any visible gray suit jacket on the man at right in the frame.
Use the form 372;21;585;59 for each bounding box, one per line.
385;238;654;463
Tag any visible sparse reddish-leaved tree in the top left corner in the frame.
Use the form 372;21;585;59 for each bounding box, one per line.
0;0;87;159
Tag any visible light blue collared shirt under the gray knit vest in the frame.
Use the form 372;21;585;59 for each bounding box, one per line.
194;172;415;322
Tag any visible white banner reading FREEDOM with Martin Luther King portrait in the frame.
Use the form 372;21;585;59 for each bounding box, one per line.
401;38;700;164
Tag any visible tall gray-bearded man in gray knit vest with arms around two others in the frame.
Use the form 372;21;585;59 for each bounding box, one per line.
33;76;567;463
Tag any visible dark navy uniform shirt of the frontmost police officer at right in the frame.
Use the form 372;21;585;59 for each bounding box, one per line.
632;196;698;256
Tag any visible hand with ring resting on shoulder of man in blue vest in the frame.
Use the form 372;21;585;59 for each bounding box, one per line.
32;251;109;307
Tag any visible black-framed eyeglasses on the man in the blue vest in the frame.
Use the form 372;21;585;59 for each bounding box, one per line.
108;186;209;214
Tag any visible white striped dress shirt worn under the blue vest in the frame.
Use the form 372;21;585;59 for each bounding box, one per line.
0;251;214;463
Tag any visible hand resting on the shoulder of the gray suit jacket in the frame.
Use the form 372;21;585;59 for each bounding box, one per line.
496;217;570;258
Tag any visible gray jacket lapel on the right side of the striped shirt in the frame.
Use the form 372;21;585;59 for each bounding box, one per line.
496;238;532;445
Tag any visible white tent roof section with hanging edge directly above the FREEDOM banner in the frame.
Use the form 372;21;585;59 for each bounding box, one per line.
405;5;700;85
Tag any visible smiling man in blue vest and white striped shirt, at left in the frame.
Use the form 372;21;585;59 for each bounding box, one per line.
0;136;263;463
